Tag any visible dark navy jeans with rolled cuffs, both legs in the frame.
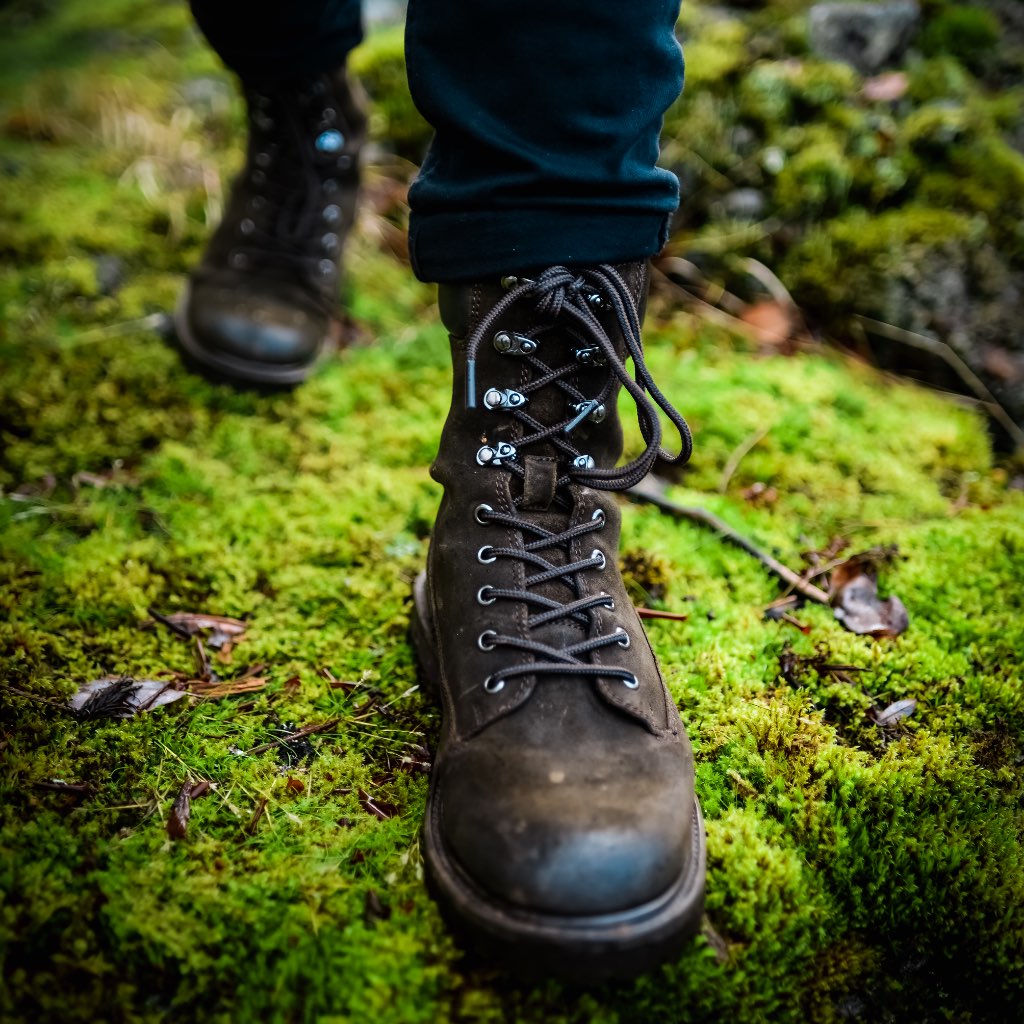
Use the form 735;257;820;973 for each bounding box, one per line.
191;0;683;282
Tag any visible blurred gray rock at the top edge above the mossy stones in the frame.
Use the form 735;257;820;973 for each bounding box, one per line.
809;0;921;75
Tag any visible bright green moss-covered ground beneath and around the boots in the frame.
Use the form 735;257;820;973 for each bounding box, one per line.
0;0;1024;1024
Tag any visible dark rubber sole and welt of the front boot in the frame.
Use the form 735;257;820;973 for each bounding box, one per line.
411;573;707;984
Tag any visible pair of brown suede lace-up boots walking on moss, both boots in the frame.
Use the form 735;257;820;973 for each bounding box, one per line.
177;66;705;979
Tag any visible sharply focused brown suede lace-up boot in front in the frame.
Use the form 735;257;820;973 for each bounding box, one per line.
413;263;705;980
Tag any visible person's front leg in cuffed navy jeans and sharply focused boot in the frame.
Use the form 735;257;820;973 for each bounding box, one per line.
407;0;705;981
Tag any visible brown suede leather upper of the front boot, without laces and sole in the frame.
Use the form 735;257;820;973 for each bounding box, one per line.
419;263;694;915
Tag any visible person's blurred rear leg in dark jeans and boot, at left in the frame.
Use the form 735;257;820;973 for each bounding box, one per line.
175;0;366;385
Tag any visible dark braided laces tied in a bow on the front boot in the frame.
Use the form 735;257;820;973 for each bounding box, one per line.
466;264;692;693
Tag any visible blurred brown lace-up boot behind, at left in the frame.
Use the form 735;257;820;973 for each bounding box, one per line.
175;69;366;386
